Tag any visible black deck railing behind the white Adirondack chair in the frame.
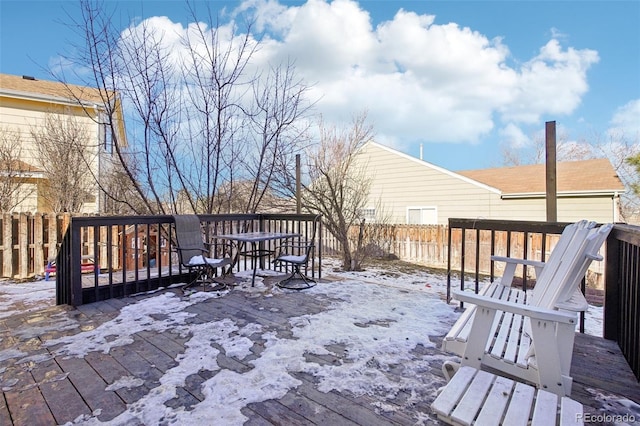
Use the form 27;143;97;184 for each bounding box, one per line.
447;219;640;380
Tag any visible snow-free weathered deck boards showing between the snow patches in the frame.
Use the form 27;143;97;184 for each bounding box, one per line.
0;278;640;426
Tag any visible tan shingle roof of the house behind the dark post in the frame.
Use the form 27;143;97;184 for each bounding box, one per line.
458;158;625;194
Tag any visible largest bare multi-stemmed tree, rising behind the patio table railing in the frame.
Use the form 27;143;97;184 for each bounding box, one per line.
60;0;309;213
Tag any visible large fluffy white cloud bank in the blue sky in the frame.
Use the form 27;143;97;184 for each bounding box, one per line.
110;0;598;146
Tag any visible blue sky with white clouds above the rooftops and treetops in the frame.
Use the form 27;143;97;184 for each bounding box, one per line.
0;0;640;171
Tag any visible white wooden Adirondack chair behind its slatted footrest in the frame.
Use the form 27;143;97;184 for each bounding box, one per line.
443;224;611;396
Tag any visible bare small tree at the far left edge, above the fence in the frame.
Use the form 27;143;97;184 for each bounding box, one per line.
0;127;35;212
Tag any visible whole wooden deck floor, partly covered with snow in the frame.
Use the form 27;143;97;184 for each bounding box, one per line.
0;268;640;426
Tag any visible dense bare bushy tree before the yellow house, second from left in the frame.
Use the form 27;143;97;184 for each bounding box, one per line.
31;114;97;213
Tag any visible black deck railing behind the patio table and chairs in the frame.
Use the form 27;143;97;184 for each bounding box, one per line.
56;214;323;306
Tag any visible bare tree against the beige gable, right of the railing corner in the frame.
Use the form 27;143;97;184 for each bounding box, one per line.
303;113;372;271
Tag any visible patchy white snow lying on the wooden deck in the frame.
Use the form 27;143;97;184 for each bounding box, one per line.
0;259;640;425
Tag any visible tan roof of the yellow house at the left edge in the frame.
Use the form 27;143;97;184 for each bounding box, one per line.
0;74;103;104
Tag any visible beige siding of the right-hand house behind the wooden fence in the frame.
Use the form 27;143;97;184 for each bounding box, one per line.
357;143;623;225
